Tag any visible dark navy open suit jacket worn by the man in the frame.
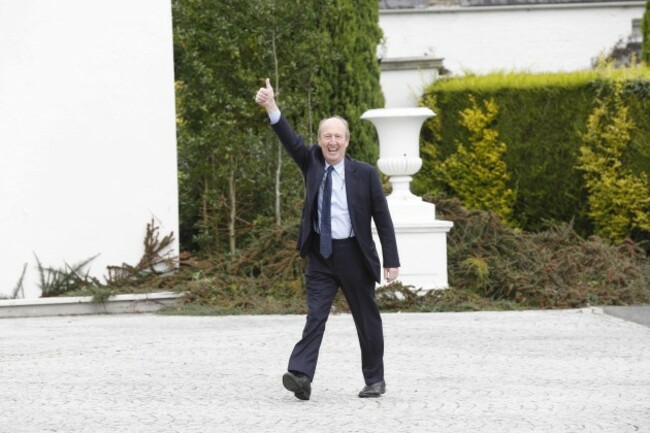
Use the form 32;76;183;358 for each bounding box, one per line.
272;116;400;282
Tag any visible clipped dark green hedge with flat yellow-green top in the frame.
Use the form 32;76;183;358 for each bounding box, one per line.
413;67;650;235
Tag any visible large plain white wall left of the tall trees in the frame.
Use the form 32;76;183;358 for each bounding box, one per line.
0;0;178;298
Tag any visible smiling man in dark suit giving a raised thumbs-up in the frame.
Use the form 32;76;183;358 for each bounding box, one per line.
255;78;400;400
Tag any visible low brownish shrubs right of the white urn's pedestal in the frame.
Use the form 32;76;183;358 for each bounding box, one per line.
436;196;650;308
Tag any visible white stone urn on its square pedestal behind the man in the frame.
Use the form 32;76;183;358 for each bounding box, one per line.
361;108;453;291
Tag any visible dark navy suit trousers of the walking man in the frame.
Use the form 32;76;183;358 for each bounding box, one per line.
289;236;384;385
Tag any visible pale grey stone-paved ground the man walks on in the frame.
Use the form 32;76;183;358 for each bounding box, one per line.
0;308;650;433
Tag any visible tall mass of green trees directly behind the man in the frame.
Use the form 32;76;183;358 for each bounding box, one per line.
172;0;383;253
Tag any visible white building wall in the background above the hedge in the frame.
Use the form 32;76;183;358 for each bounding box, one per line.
379;1;645;74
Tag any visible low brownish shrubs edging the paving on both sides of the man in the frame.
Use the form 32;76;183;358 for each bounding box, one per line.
82;197;650;314
